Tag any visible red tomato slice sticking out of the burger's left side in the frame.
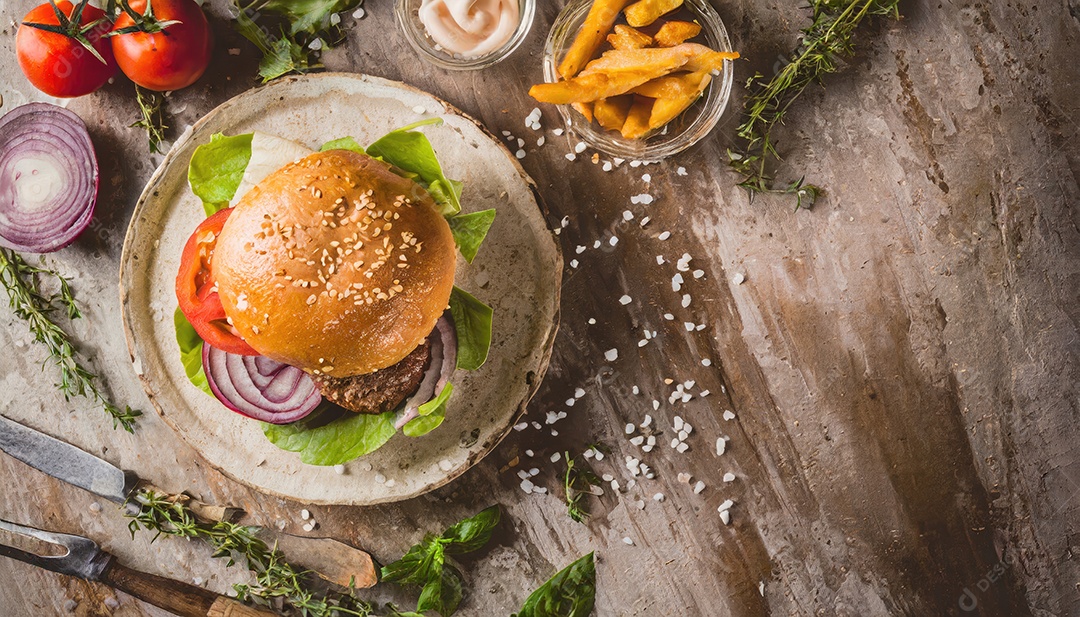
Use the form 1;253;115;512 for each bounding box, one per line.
176;207;259;356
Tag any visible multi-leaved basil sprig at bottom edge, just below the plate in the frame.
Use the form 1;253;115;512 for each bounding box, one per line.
381;506;501;617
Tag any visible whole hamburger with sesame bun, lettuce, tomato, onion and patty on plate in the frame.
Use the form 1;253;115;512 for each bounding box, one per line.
176;126;495;465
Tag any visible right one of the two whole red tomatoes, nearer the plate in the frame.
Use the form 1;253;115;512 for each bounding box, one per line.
110;0;214;91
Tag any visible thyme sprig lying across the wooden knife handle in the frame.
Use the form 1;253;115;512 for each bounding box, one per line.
125;491;372;617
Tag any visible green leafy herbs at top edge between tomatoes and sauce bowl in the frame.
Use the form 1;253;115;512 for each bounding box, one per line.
233;0;363;83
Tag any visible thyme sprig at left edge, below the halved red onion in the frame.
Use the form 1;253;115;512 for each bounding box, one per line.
0;249;143;433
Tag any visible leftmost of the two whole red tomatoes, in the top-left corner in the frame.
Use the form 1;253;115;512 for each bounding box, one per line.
15;0;117;98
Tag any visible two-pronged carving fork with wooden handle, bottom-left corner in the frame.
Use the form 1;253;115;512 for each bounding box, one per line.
0;520;278;617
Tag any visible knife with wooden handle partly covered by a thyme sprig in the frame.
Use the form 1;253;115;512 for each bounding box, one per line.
0;415;378;589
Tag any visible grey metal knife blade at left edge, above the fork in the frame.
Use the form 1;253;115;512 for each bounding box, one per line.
0;416;139;504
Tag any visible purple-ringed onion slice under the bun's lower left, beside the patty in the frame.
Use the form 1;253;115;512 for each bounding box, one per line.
203;344;323;425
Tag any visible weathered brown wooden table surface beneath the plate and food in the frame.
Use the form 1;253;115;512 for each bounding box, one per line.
0;0;1080;617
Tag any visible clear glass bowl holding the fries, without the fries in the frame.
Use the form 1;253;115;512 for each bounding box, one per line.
543;0;734;161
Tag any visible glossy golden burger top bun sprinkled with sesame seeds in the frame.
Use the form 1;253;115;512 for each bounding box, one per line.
211;150;457;377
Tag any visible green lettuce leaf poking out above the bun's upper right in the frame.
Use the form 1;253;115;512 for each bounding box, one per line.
367;118;461;216
